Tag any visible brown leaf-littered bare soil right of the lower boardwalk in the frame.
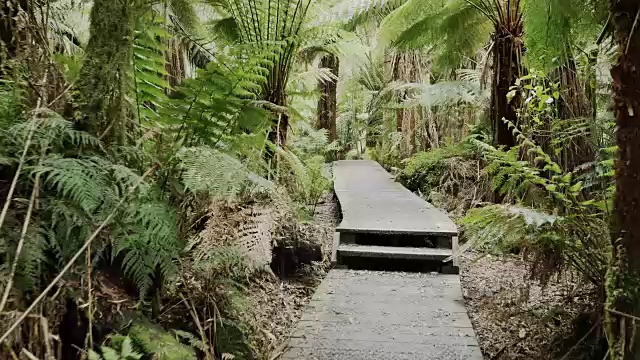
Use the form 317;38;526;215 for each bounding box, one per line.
460;253;604;360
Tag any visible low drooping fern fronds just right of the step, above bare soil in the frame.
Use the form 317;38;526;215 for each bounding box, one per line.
462;205;610;289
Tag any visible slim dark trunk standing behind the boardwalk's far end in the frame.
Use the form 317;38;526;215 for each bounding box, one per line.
316;54;340;142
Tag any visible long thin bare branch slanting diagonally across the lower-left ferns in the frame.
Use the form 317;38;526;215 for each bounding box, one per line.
0;164;159;343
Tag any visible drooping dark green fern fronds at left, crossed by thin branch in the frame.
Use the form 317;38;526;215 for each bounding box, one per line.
1;107;180;295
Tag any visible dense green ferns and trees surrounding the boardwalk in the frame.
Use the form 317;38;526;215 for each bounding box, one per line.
0;0;640;360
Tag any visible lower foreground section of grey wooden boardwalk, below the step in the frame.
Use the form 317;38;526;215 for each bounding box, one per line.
282;269;482;360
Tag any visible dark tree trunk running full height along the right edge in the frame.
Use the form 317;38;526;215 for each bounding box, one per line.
606;0;640;360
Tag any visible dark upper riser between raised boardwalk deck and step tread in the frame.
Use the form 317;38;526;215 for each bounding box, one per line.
340;233;452;249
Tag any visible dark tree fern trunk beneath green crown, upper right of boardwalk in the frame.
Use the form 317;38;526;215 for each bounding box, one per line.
490;27;522;148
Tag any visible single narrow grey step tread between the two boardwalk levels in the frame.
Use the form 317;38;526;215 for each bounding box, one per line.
337;244;453;261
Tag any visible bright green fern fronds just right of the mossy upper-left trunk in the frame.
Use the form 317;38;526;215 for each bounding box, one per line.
163;46;277;151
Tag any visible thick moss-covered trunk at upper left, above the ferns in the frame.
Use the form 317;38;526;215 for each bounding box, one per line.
76;0;134;143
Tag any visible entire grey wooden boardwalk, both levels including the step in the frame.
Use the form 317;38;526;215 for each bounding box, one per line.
282;161;483;360
